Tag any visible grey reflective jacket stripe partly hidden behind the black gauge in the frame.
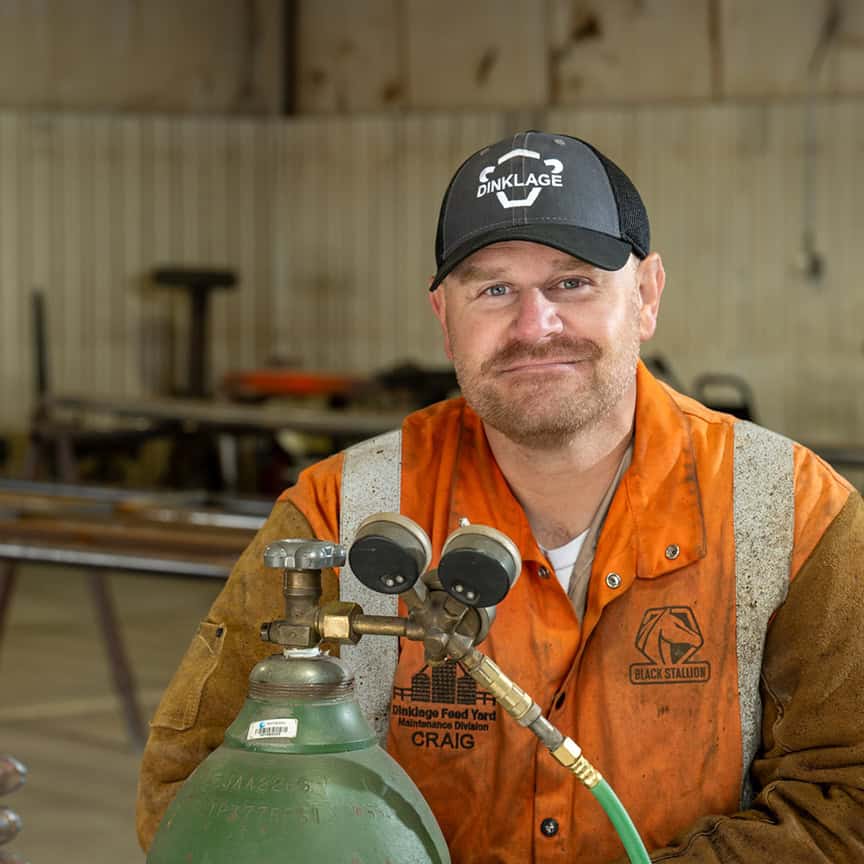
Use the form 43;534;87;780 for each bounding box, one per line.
339;429;402;743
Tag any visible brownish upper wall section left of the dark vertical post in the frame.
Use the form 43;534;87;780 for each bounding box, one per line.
0;0;284;115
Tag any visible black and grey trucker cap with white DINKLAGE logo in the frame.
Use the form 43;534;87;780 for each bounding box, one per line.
430;132;650;291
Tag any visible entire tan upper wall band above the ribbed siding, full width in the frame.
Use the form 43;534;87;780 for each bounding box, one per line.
0;0;864;116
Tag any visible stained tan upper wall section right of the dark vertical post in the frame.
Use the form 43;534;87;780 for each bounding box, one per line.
297;0;864;114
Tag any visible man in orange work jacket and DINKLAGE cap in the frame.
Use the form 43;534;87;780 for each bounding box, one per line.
139;132;864;864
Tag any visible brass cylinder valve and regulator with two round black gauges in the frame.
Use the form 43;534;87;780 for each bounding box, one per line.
261;513;510;664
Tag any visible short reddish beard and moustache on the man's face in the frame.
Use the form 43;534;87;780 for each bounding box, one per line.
453;315;640;449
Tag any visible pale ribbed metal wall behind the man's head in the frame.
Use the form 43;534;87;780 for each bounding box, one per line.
0;101;864;441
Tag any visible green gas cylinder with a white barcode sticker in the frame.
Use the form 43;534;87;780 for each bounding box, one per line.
147;649;450;864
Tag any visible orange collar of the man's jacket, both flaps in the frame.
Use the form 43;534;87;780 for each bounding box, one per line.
448;362;705;582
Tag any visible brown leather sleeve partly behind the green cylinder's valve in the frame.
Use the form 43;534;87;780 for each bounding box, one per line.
136;501;337;852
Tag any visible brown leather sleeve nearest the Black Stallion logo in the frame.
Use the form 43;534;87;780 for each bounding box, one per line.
637;493;864;864
